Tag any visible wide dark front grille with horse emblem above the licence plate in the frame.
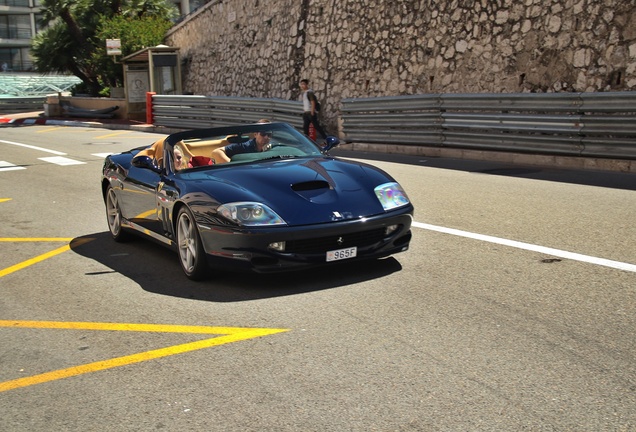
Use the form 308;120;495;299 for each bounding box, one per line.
285;228;384;254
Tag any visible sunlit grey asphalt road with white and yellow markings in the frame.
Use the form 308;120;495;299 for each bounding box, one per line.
0;126;636;432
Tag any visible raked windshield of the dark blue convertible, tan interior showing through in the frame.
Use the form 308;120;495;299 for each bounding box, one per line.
166;123;321;171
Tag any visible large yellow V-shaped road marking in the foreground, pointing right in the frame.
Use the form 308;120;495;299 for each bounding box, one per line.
0;320;289;392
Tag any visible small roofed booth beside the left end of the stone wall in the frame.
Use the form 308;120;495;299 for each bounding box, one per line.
121;45;182;120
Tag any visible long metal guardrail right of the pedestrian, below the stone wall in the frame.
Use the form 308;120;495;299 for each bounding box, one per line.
341;92;636;159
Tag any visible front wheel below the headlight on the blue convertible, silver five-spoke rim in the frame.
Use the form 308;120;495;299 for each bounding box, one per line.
177;207;208;280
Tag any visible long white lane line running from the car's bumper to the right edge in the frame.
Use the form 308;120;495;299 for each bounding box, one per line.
413;222;636;273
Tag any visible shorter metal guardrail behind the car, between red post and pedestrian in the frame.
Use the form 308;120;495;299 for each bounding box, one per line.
152;95;302;129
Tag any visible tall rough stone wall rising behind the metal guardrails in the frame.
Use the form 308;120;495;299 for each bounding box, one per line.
166;0;636;126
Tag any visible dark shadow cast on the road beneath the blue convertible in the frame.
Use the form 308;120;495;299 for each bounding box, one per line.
71;232;402;302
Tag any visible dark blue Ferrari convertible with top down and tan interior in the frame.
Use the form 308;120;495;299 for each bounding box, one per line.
101;123;414;280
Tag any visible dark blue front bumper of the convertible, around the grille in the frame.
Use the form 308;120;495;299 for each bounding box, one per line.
199;206;413;273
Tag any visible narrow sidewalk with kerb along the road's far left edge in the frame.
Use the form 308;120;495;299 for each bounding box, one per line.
0;111;166;134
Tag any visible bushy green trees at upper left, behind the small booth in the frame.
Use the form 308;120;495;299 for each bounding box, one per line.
31;0;178;96
